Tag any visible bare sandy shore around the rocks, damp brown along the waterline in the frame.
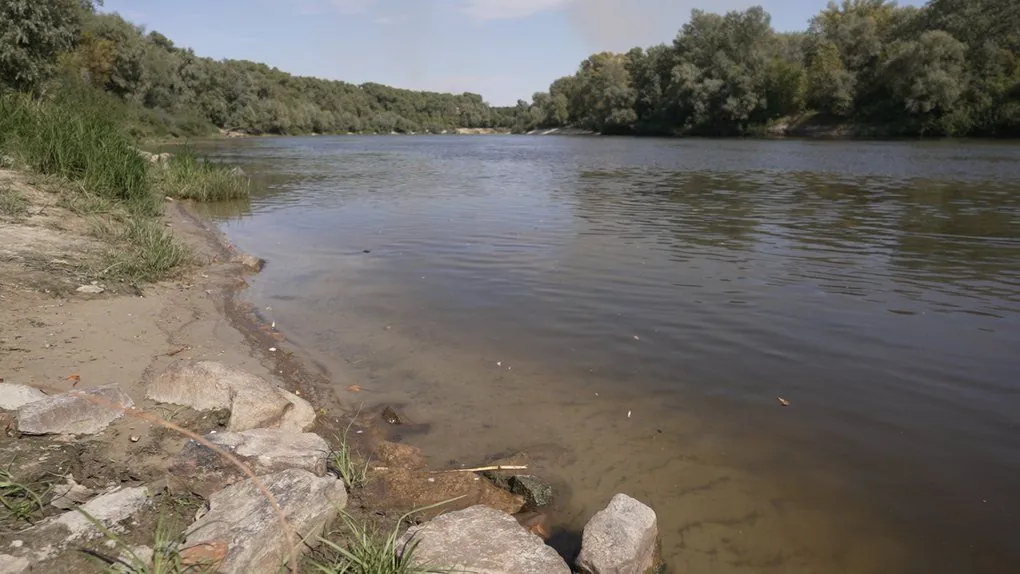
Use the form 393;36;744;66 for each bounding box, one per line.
0;171;567;572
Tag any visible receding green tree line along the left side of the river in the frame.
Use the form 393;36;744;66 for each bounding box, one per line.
0;0;518;134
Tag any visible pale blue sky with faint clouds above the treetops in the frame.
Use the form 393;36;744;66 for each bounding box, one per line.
104;0;921;105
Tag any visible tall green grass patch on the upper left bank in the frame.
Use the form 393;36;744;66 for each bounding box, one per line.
0;95;158;214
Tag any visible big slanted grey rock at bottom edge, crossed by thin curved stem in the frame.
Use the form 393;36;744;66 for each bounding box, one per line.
185;469;347;574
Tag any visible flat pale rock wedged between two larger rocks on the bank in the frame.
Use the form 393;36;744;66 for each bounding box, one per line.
169;428;329;495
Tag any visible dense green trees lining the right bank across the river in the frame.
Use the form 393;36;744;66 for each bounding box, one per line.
519;0;1020;136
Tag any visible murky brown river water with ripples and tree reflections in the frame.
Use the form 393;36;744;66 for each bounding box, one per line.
196;137;1020;573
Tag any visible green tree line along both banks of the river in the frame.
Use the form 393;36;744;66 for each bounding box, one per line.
0;0;1020;136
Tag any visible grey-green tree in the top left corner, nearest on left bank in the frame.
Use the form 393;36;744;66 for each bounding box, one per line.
0;0;93;92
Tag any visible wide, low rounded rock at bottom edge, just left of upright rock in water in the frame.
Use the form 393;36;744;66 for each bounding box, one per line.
397;505;570;574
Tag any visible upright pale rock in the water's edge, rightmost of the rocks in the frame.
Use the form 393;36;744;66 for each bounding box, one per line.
577;494;659;574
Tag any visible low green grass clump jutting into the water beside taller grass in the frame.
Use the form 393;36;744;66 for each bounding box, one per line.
152;150;251;201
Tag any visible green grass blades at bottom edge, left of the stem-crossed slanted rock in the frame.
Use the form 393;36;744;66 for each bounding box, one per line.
78;508;215;574
